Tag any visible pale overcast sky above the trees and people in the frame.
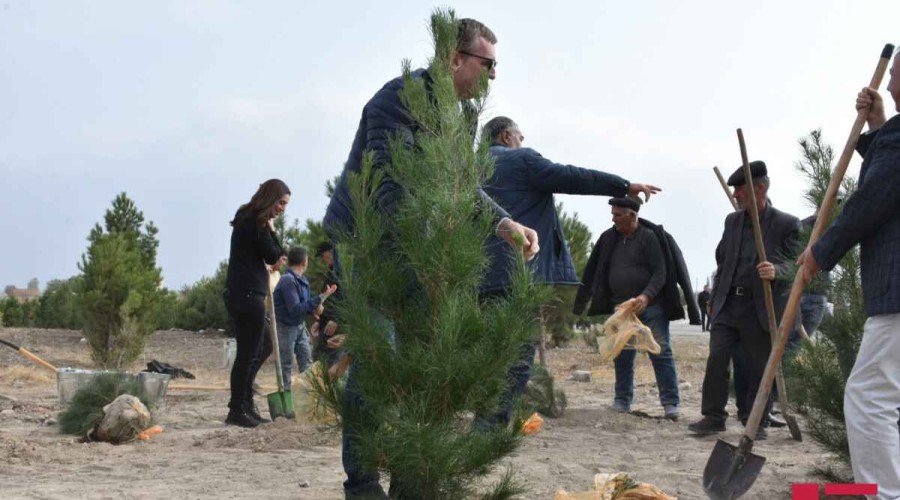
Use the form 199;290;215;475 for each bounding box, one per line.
0;0;900;288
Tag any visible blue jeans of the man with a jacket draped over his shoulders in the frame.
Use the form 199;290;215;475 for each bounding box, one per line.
615;304;681;408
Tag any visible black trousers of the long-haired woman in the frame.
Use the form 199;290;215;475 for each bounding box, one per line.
225;292;272;411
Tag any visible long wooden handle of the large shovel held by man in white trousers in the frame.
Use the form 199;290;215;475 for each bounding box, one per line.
747;44;894;440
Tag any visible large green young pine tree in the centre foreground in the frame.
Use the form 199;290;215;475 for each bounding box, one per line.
326;11;542;499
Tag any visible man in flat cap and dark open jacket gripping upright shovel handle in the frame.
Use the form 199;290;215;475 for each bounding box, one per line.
688;161;800;440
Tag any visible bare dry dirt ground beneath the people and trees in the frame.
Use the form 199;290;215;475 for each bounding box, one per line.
0;325;844;500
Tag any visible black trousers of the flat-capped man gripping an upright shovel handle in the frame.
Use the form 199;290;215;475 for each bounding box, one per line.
701;295;772;422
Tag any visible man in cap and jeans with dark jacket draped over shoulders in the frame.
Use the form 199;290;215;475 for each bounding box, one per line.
575;198;700;420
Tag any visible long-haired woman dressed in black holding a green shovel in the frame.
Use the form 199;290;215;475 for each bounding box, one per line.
225;179;291;427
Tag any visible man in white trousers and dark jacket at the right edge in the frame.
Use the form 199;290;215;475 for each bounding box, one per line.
797;52;900;500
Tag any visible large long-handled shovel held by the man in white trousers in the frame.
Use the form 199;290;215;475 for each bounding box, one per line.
703;44;894;500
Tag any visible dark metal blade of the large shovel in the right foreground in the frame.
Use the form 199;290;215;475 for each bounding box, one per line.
703;436;766;500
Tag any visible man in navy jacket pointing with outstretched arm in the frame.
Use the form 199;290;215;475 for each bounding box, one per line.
476;116;659;425
